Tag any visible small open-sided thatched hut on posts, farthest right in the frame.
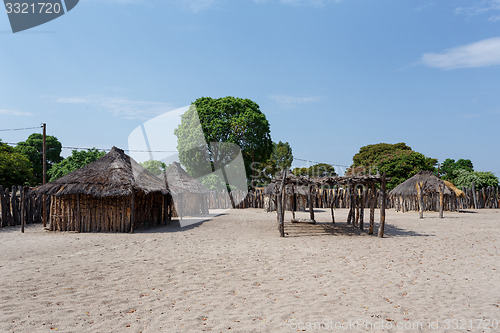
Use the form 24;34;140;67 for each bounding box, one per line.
389;171;463;212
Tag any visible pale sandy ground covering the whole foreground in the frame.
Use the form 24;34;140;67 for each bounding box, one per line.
0;209;500;332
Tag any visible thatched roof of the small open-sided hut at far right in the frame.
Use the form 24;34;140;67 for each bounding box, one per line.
389;171;451;197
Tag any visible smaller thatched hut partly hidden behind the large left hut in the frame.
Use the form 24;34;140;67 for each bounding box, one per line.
161;162;210;217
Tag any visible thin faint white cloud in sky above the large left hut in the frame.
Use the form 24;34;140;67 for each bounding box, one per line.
54;96;174;119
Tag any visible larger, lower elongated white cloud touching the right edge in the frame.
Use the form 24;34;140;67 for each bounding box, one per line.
420;37;500;69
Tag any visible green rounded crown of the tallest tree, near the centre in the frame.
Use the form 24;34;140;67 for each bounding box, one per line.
174;97;273;184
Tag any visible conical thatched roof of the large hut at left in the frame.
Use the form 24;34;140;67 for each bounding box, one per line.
34;147;169;197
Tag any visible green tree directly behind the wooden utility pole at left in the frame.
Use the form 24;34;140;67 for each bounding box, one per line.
15;133;63;184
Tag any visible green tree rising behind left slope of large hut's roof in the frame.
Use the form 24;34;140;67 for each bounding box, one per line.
47;148;106;182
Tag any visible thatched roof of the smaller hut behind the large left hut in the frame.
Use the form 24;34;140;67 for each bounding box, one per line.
160;162;210;195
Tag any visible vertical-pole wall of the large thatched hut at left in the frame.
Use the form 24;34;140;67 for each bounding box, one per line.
50;193;169;232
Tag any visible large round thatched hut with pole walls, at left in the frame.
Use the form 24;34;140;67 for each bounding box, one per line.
35;147;171;232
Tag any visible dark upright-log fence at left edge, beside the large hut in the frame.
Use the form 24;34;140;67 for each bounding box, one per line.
0;185;50;228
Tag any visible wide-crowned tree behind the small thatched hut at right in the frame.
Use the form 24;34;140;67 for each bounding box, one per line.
349;142;437;190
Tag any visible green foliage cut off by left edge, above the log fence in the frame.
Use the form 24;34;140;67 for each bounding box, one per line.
0;140;33;188
